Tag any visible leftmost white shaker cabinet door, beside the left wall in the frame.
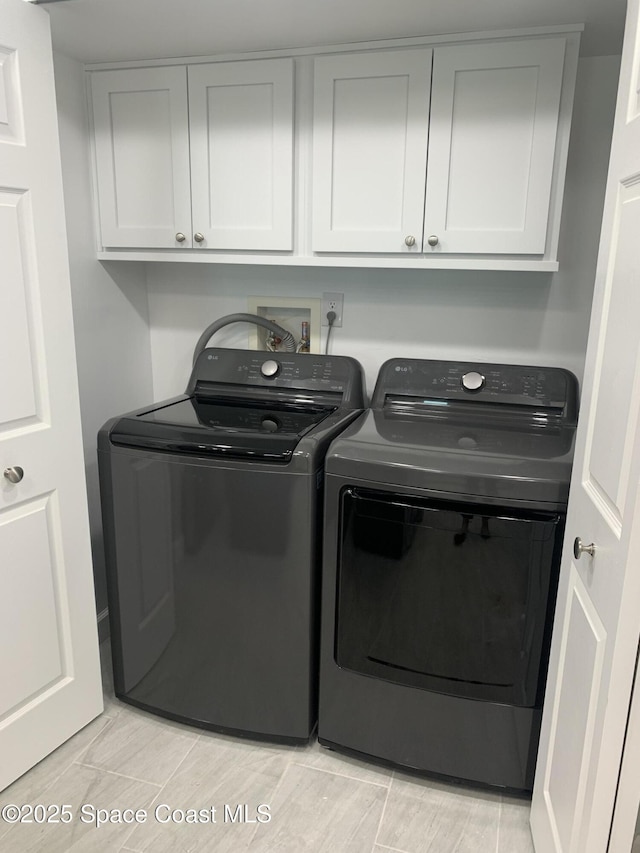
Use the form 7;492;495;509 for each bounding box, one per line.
91;66;191;249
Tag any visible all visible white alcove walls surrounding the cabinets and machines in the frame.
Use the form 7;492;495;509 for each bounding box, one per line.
50;43;619;648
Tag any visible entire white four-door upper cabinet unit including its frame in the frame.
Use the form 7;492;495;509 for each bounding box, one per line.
88;25;581;272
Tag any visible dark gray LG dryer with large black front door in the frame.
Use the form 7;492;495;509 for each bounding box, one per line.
318;359;578;790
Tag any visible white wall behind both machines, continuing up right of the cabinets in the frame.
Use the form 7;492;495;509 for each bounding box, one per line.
148;57;619;399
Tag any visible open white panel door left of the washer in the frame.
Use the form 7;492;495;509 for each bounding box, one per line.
0;0;102;789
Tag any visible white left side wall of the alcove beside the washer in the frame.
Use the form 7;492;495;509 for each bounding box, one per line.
54;54;152;624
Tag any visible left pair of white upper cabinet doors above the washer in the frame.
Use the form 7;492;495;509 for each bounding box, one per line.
91;59;293;250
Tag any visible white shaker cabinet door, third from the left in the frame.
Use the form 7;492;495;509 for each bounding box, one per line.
312;48;432;252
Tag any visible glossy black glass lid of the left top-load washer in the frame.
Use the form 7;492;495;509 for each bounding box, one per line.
110;396;337;462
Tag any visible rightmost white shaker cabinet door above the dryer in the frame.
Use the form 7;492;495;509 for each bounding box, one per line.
424;38;565;254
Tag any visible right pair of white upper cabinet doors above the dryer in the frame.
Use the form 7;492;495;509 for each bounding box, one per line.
312;38;565;255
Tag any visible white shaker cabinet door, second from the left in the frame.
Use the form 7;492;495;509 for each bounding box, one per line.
189;59;293;250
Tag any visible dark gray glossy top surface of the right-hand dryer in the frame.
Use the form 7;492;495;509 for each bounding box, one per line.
326;409;575;505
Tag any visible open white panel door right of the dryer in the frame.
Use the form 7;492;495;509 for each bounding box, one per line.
531;0;640;853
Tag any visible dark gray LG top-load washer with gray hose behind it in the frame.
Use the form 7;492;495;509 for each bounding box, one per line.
98;348;364;742
